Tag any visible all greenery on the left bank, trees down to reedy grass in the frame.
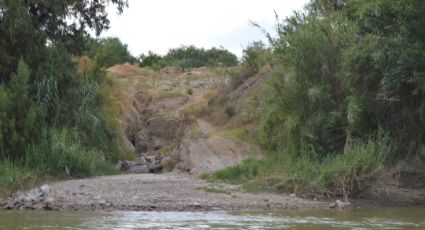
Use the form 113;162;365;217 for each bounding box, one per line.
0;0;132;196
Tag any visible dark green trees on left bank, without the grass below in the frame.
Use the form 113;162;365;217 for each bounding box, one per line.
0;0;127;159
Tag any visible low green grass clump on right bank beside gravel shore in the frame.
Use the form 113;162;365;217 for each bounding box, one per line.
203;135;392;199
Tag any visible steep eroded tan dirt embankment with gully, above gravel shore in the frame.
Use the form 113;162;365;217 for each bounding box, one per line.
115;63;255;173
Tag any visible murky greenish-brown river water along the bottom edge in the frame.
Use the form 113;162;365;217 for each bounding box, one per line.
0;206;425;229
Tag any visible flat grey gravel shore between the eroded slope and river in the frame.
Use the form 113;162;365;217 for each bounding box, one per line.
0;173;329;211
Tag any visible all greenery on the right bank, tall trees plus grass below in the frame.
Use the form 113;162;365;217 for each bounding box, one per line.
202;0;425;197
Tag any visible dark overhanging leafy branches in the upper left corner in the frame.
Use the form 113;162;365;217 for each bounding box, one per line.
0;0;127;82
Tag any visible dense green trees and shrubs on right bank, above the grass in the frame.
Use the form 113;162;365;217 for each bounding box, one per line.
262;0;425;157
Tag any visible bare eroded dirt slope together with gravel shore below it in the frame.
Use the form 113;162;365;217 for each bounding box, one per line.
0;66;327;211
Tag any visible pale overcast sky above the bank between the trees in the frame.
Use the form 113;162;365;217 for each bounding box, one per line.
101;0;308;57
